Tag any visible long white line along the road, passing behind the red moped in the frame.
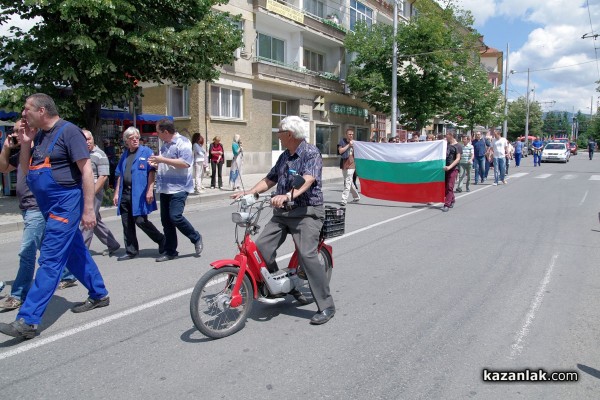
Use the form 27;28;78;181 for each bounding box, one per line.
0;185;492;360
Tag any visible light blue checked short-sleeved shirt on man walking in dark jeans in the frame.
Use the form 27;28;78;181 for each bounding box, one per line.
156;132;194;194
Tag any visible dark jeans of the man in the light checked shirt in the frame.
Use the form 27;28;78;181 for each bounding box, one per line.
160;192;201;256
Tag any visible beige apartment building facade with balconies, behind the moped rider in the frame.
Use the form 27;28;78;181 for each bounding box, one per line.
141;0;414;173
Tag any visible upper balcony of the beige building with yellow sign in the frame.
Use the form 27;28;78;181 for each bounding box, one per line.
253;0;347;43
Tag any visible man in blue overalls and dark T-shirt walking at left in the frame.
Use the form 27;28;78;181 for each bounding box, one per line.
0;93;110;339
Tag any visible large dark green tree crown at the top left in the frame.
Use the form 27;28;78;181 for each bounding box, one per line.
0;0;241;131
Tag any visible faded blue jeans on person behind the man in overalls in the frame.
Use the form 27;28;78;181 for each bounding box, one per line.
10;209;46;301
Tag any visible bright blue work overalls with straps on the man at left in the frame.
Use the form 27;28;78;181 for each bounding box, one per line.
17;122;108;325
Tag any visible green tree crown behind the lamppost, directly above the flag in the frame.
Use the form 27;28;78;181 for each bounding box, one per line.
344;0;477;129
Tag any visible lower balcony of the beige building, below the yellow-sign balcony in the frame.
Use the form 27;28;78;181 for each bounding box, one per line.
252;57;344;93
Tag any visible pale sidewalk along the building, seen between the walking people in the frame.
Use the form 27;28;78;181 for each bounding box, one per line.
0;167;342;233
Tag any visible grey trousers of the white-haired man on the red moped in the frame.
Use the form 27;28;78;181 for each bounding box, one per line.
256;206;334;311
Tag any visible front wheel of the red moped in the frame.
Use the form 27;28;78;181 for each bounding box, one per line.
190;266;254;339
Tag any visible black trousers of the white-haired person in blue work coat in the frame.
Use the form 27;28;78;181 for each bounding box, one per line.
119;188;165;255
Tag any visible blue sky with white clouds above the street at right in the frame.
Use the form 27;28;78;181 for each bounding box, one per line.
456;0;600;114
